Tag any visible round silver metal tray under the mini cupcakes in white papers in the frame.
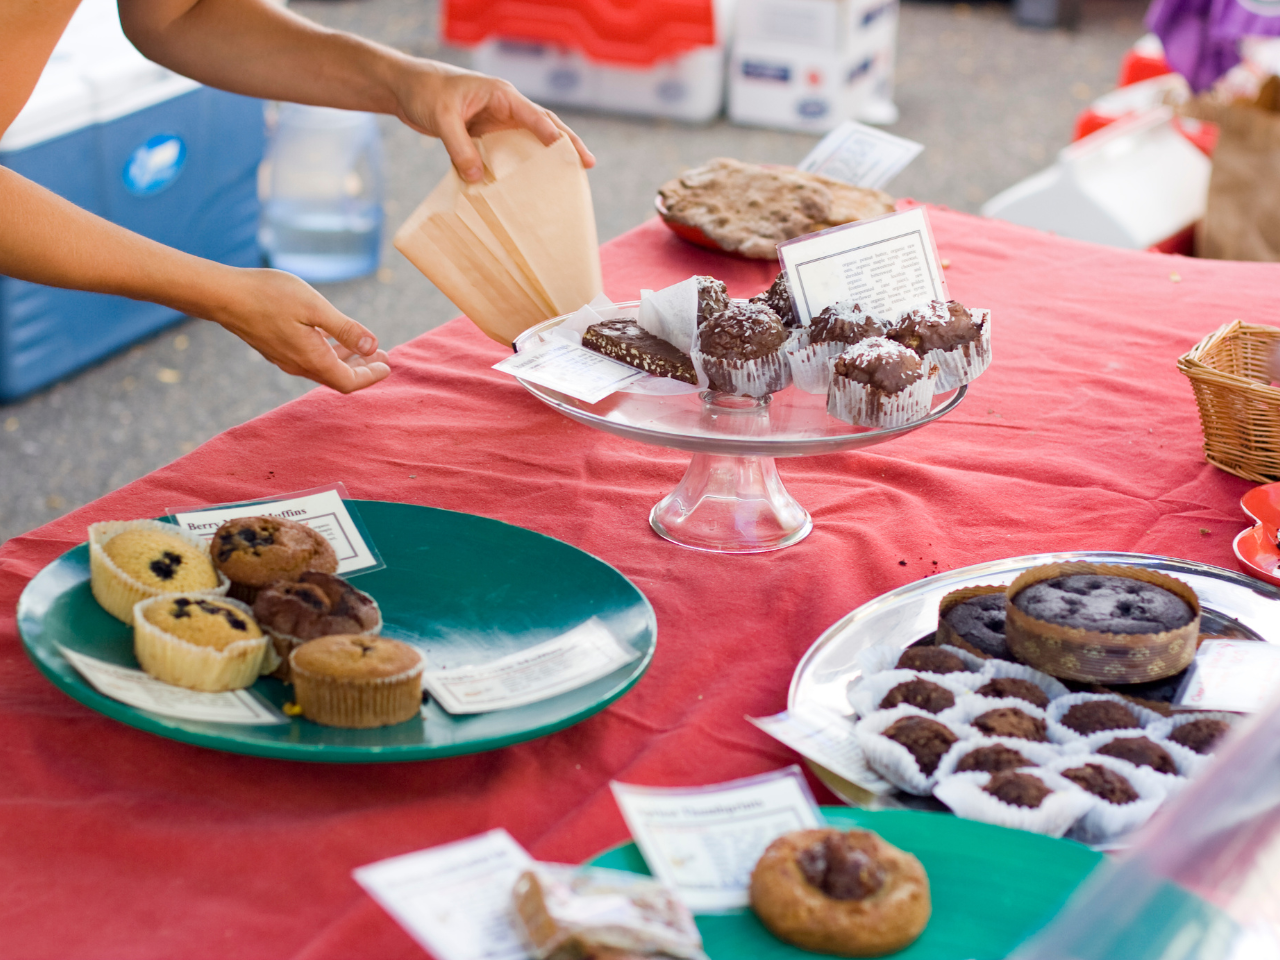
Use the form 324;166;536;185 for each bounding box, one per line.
787;550;1280;805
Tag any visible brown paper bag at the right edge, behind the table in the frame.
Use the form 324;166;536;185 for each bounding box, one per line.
1196;77;1280;260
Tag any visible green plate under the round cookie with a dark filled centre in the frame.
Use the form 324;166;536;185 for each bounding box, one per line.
588;806;1103;960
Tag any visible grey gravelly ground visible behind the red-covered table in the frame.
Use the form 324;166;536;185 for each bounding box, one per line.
0;0;1144;541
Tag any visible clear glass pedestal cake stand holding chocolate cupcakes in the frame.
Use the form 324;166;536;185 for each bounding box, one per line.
516;301;966;553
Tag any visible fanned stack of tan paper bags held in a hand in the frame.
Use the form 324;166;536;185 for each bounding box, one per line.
396;131;602;346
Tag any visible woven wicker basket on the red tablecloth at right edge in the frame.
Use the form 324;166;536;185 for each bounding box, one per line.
1178;320;1280;483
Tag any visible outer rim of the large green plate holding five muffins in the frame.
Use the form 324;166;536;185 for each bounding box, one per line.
17;500;658;763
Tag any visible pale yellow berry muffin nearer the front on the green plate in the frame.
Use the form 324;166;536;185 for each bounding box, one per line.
133;594;268;691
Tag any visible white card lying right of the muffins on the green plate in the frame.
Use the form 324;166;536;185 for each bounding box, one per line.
422;617;640;714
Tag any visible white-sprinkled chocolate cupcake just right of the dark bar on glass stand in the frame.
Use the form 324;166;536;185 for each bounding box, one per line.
692;302;791;397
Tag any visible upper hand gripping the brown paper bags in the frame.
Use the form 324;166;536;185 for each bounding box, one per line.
397;60;595;183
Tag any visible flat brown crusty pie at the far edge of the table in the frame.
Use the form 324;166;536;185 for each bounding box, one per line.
658;157;893;260
